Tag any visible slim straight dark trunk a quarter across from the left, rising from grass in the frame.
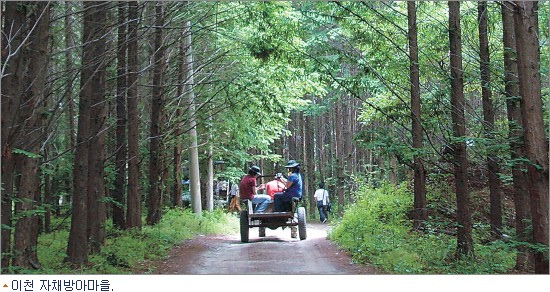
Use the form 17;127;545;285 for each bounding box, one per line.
126;1;141;228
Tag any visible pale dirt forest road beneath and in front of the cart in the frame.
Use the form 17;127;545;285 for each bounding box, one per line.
153;223;376;275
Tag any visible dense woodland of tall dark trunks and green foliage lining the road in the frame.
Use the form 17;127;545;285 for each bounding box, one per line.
1;1;550;273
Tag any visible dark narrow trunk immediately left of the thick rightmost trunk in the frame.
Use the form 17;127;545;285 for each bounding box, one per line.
502;2;533;272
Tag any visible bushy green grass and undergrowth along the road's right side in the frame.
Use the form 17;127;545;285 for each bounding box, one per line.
329;184;516;274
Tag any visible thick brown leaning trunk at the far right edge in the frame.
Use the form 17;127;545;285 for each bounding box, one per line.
514;2;548;274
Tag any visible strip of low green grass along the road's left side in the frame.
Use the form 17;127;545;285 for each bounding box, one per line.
26;209;238;274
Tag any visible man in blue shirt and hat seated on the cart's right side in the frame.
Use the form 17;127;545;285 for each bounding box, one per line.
273;160;302;212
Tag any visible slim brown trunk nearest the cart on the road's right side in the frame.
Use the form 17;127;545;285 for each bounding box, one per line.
407;1;428;230
